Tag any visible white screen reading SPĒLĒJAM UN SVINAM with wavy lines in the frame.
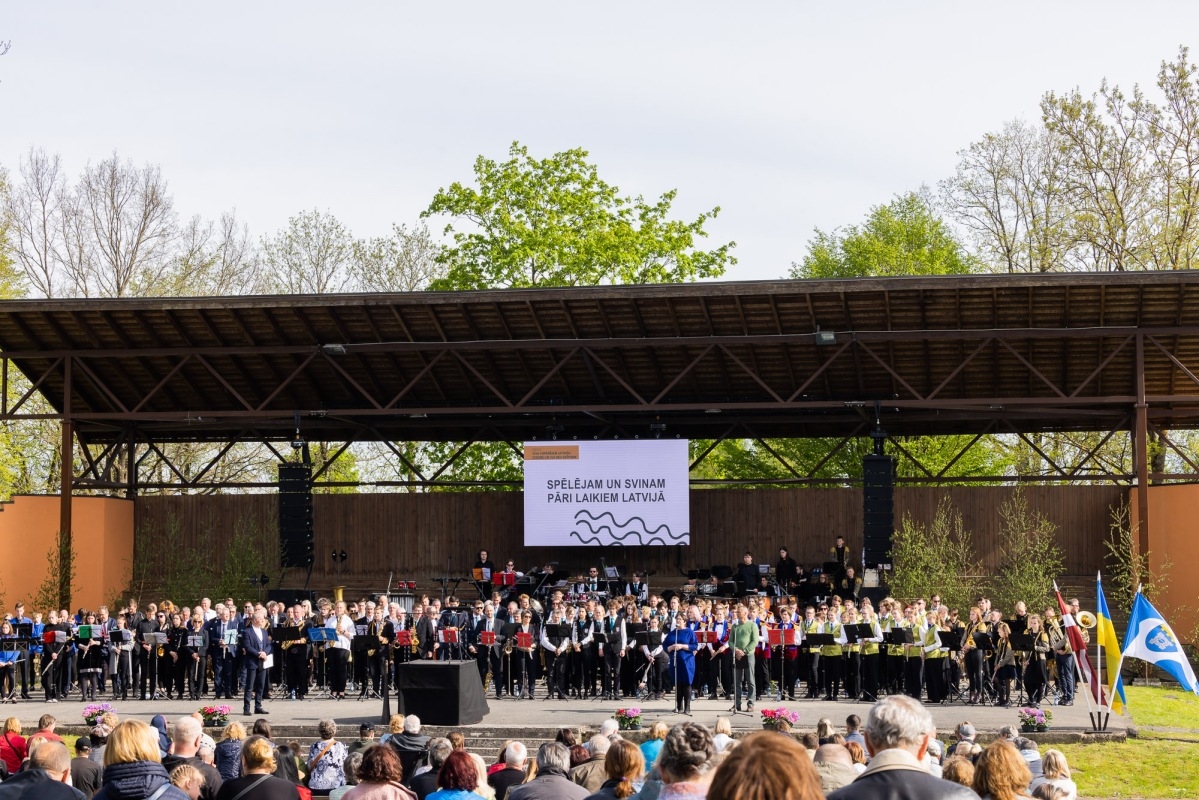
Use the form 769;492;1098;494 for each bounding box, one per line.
524;439;691;547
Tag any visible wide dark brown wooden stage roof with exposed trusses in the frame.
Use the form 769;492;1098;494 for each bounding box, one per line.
0;272;1199;441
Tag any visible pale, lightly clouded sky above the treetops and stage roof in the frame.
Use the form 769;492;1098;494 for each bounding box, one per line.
0;0;1199;279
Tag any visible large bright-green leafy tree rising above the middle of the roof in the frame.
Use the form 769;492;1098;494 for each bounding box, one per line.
422;142;736;290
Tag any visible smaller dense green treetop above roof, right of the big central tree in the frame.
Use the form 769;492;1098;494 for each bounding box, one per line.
791;192;976;278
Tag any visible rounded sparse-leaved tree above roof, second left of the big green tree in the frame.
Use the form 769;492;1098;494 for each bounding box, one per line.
263;209;354;294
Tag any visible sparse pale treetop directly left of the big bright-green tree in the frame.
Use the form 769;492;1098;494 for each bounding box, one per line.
350;222;445;291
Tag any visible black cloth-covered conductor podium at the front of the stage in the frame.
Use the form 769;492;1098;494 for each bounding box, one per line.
396;660;490;726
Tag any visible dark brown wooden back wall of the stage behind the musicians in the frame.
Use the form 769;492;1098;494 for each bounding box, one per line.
137;486;1127;591
